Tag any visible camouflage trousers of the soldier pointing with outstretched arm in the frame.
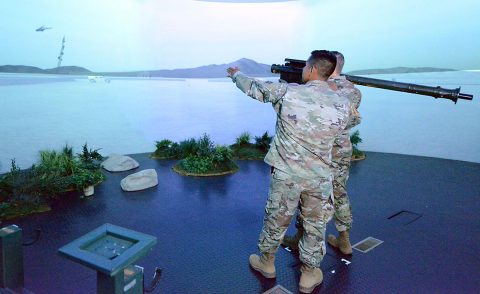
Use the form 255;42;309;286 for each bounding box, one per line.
258;169;334;267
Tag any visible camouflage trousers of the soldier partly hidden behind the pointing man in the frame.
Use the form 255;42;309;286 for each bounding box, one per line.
332;131;352;232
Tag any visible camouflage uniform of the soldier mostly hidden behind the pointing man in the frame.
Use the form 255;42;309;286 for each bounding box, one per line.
331;76;362;232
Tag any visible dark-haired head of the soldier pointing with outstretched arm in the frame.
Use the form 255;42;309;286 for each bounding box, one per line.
302;50;337;83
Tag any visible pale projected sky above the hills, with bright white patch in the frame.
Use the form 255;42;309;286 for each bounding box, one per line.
0;0;480;71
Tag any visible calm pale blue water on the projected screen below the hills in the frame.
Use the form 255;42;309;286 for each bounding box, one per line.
0;71;480;172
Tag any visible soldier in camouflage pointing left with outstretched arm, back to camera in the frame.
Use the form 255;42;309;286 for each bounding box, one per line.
227;50;350;293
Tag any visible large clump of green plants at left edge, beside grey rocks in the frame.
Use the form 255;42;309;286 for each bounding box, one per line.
0;144;105;218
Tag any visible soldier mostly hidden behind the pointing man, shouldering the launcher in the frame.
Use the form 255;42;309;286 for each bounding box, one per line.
282;51;362;254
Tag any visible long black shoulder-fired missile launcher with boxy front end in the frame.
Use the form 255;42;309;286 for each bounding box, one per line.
271;58;473;103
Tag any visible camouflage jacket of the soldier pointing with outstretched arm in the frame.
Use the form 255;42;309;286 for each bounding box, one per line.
232;72;351;180
